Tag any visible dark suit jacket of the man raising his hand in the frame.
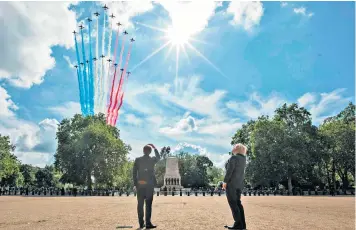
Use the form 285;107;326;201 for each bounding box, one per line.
132;149;160;186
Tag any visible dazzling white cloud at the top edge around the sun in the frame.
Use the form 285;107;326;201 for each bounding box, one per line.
159;1;220;37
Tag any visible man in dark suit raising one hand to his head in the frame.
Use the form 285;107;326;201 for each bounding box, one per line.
132;144;160;229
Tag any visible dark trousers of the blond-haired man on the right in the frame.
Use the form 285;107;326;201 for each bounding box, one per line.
226;186;246;229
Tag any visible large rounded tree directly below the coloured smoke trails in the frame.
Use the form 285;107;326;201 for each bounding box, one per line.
55;114;131;188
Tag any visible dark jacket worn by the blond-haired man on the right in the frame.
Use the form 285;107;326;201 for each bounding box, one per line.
224;154;246;190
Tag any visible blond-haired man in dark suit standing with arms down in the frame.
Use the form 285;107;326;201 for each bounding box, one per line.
223;144;247;230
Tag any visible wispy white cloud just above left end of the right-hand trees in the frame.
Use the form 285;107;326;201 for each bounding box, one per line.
226;92;287;119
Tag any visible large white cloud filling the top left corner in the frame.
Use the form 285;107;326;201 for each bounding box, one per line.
0;2;76;88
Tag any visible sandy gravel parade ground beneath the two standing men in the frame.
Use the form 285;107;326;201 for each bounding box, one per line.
0;196;355;230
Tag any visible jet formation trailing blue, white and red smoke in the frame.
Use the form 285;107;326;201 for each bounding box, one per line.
73;4;135;126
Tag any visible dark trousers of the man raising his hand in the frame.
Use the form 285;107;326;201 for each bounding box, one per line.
137;185;154;225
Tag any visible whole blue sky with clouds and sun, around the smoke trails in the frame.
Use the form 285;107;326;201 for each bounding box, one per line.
0;1;355;167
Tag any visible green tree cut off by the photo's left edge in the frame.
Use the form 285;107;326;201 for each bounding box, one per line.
0;134;23;186
